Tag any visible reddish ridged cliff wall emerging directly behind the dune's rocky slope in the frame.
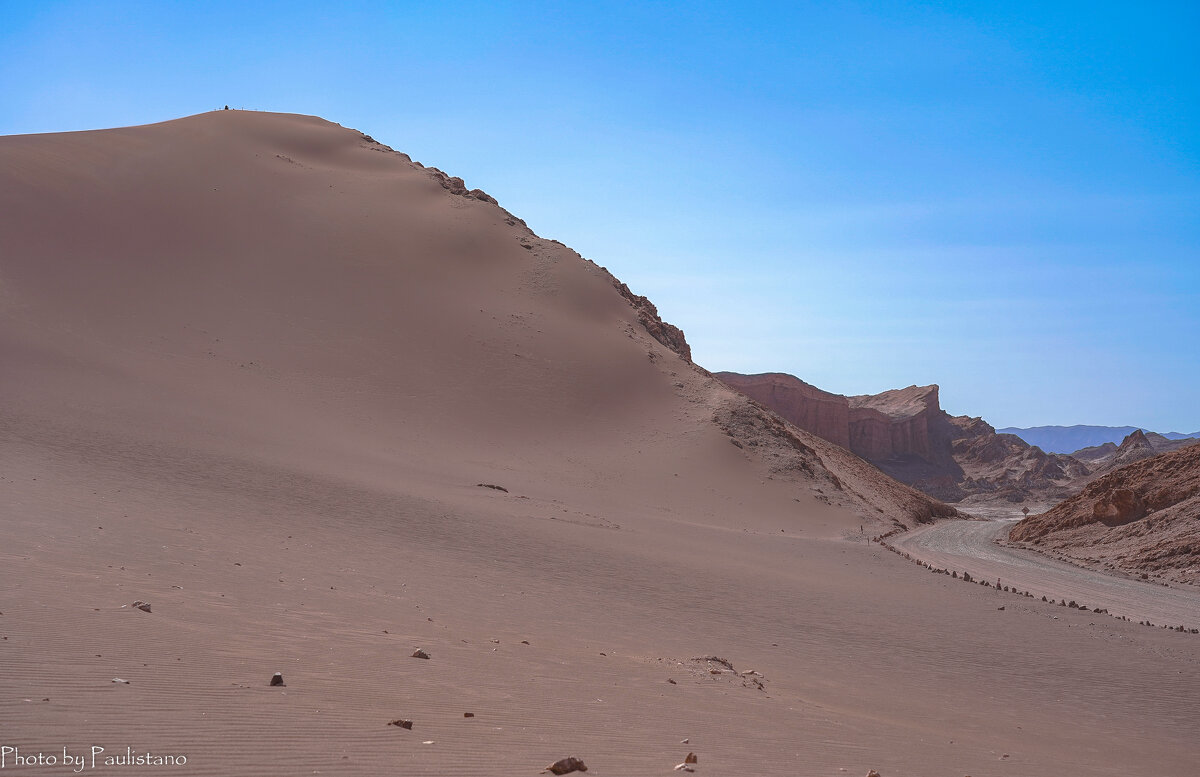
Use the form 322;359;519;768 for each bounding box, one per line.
716;372;852;450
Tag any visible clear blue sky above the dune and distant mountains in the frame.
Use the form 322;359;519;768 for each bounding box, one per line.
0;0;1200;432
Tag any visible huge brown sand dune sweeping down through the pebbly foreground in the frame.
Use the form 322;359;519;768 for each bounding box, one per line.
0;112;1200;777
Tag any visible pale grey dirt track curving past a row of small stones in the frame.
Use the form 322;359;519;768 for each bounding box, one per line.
889;520;1200;628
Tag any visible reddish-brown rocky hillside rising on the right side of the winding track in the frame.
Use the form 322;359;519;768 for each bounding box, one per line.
1009;435;1200;583
